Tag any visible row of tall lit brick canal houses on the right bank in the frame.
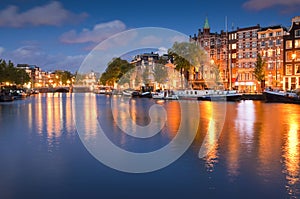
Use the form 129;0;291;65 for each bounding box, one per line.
190;16;300;92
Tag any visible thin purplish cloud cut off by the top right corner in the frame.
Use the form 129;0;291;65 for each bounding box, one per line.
243;0;300;11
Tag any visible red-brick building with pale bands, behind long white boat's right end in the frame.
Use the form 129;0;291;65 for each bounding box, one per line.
235;24;260;92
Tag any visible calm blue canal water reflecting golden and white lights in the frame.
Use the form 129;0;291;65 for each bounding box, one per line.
0;93;300;199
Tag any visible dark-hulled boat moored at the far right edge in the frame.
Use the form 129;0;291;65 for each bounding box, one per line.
263;90;300;104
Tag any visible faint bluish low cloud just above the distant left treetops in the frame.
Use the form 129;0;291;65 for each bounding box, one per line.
2;46;86;72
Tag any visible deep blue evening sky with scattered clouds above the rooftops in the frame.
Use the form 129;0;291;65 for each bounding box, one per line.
0;0;300;71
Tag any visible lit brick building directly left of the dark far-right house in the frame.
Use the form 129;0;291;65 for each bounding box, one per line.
258;25;287;88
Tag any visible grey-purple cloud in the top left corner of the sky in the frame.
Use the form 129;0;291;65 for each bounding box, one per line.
0;1;87;27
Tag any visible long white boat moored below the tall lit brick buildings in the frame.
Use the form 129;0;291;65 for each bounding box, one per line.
197;90;242;102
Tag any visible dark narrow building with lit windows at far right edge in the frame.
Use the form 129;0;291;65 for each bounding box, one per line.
283;16;300;90
